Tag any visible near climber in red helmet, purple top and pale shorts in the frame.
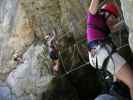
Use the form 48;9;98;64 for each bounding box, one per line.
86;0;133;100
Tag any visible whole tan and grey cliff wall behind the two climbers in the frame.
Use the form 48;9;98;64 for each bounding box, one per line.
0;0;133;100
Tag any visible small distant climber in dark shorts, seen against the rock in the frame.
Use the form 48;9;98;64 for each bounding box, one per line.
45;32;59;76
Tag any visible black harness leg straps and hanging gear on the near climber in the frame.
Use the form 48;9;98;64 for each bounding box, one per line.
93;43;116;93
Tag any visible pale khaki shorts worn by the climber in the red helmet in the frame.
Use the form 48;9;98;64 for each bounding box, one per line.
88;44;126;75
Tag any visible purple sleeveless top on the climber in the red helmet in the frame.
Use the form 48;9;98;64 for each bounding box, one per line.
86;13;108;43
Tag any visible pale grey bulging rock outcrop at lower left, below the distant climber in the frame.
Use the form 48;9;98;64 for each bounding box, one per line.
7;45;52;100
